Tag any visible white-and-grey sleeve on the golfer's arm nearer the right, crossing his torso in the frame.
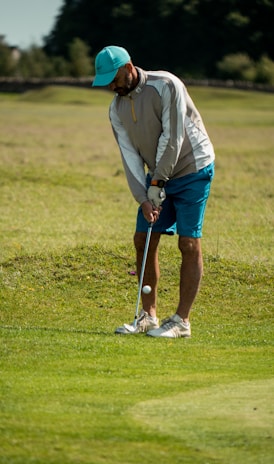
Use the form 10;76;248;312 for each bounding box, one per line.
153;80;186;181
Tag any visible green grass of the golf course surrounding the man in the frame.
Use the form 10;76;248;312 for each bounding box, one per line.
0;88;274;464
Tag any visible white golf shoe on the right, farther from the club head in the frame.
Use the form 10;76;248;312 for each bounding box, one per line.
147;314;191;338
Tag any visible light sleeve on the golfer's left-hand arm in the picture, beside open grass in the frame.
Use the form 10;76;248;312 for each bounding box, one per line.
109;103;147;205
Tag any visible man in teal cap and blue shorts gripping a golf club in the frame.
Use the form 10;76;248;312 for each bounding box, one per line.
93;46;215;338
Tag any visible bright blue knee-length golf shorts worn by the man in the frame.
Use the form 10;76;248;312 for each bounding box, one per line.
136;162;214;238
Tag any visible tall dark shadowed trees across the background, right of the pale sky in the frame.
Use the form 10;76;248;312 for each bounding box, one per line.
0;0;274;84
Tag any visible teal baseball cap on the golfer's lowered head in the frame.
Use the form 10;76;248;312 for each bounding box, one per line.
92;45;131;87
